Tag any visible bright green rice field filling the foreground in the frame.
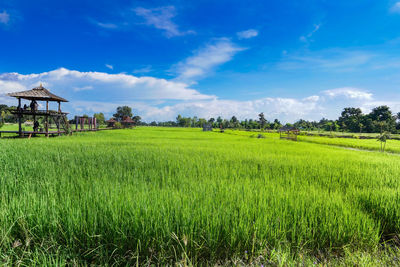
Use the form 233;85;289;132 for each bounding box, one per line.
0;127;400;266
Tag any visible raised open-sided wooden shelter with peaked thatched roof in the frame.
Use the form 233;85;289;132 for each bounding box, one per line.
3;84;70;137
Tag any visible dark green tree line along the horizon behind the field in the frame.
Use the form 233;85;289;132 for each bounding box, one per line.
0;104;400;133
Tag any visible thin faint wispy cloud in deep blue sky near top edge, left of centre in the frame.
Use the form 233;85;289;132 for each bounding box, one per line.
133;6;194;37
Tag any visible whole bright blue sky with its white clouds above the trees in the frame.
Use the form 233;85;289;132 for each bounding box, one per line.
0;0;400;122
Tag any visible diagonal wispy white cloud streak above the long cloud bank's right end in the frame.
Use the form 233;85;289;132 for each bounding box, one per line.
173;38;244;81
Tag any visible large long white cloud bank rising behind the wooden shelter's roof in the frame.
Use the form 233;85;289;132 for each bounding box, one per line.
0;68;214;102
